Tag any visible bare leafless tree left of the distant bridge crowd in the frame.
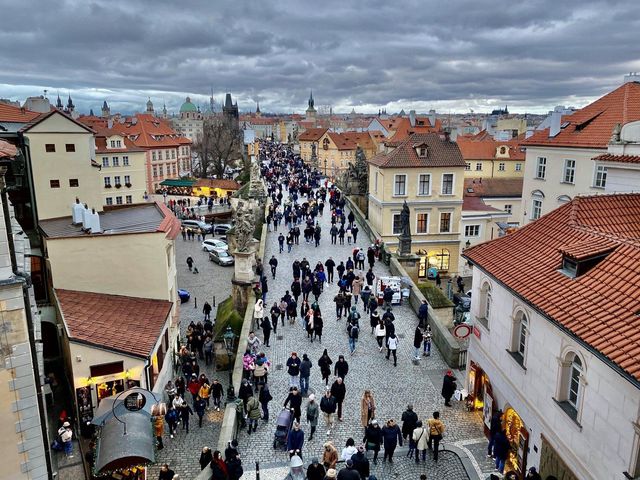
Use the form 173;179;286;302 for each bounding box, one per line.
193;116;243;178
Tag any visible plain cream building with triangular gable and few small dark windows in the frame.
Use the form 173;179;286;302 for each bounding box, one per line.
22;110;104;220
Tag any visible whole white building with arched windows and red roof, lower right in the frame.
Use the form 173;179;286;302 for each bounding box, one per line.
464;194;640;480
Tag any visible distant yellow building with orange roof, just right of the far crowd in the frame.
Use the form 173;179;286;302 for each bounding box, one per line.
318;131;378;176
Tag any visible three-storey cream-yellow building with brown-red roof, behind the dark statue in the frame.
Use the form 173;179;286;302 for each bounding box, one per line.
368;133;465;277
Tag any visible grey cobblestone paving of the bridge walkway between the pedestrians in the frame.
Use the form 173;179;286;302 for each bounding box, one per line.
232;184;492;478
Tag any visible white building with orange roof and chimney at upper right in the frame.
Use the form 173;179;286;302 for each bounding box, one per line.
521;75;640;225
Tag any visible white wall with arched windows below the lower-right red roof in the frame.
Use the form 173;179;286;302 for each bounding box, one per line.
467;267;640;480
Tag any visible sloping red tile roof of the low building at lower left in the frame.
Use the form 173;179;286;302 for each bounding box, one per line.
55;289;172;358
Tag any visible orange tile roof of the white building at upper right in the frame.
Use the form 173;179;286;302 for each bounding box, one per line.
523;82;640;148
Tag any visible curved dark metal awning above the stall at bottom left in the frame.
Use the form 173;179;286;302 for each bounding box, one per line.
95;410;155;474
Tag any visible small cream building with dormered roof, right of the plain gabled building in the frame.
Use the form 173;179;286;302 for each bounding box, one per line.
95;129;147;206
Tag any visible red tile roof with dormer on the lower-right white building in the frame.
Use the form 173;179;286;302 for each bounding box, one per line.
463;194;640;382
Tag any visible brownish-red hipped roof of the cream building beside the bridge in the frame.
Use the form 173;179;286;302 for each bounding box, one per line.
367;133;465;168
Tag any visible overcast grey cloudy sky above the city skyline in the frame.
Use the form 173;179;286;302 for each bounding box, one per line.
0;0;640;113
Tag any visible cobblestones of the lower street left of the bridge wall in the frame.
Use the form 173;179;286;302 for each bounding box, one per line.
148;236;233;480
